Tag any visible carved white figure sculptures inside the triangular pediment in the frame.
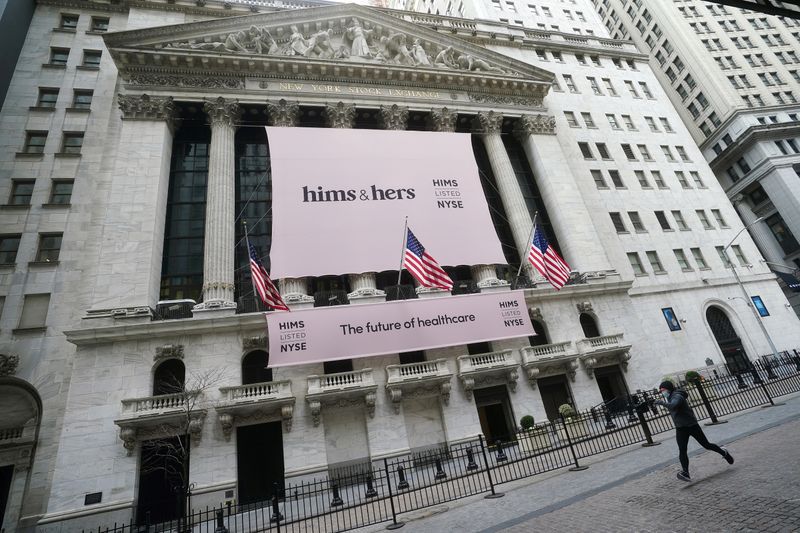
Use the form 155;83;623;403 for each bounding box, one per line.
163;17;517;76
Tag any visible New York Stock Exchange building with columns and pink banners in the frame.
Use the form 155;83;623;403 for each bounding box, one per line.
0;0;800;531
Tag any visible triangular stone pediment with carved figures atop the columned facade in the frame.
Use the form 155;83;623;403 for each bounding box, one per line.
104;4;553;102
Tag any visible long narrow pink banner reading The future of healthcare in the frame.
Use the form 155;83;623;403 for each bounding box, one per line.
267;291;534;367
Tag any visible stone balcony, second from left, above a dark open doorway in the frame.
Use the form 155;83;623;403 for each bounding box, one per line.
216;380;295;439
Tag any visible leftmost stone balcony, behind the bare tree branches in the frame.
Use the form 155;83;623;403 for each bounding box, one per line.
114;392;207;455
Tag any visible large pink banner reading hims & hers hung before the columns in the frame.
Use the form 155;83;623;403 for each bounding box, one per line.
267;128;506;279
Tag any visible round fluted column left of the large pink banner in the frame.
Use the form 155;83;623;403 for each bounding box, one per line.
194;97;241;313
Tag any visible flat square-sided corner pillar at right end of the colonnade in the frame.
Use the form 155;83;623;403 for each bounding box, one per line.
515;115;612;271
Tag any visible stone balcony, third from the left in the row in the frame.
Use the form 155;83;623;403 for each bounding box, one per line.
306;368;378;426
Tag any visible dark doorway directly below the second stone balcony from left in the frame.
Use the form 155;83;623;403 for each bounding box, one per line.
236;422;283;504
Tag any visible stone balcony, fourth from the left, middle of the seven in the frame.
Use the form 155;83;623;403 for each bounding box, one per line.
386;359;453;413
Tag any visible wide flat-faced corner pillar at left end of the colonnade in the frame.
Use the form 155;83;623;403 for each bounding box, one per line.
85;94;176;324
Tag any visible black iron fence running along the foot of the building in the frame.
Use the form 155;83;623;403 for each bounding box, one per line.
86;350;800;533
